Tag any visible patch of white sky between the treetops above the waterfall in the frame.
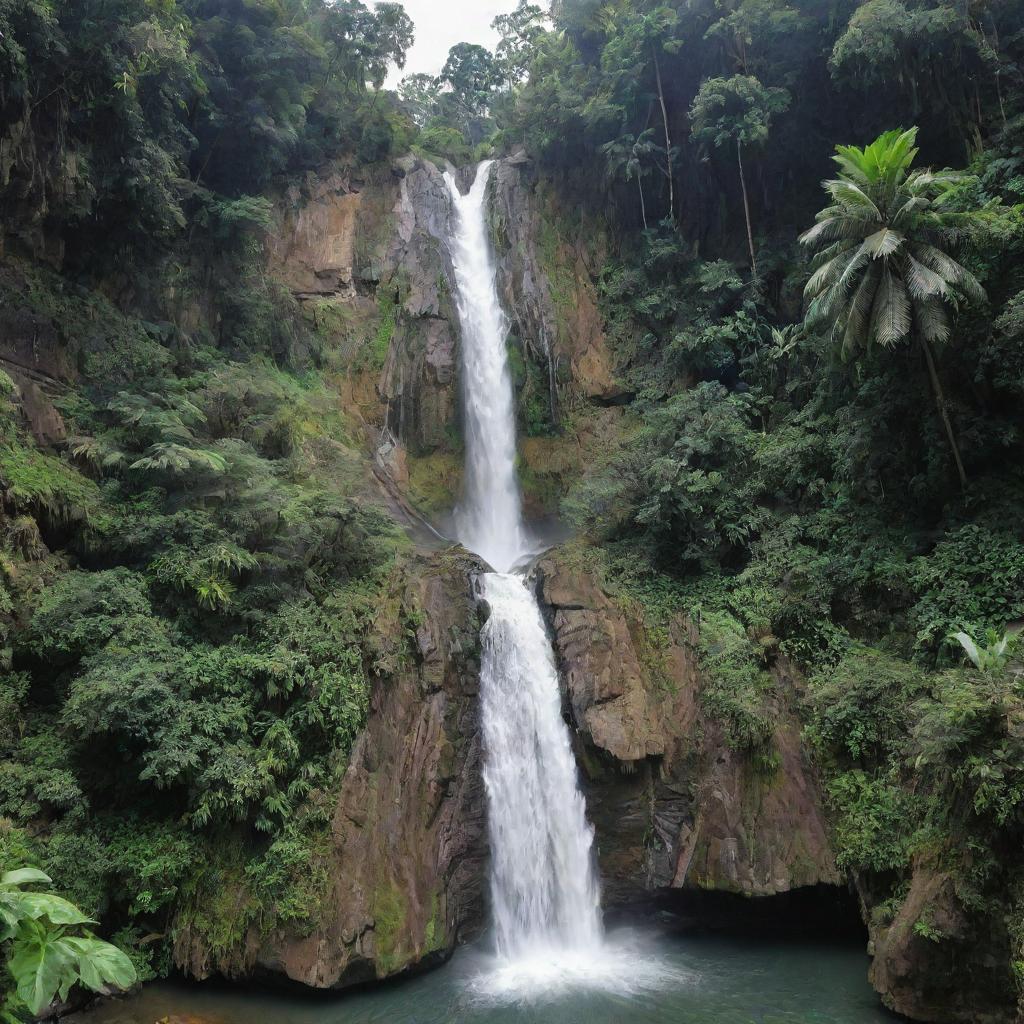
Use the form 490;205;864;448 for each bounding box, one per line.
385;0;516;89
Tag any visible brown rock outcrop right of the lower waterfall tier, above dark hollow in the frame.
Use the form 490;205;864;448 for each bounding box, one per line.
538;554;841;904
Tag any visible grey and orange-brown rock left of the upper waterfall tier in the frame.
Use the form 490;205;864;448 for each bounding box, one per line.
267;157;459;454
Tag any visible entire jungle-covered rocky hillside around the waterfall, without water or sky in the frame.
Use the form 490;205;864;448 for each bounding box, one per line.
0;0;1024;1024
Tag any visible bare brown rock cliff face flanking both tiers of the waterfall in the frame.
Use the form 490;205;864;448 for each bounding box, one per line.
260;151;839;966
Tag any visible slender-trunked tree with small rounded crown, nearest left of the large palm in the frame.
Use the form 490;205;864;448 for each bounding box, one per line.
690;75;790;284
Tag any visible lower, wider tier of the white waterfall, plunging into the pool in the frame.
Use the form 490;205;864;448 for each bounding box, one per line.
480;573;601;959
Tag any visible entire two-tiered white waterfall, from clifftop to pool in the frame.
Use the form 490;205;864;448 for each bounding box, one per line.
445;162;602;975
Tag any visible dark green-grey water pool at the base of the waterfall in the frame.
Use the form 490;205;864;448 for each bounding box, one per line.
74;930;897;1024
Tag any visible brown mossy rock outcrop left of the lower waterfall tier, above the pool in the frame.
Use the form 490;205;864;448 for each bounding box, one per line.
175;550;487;988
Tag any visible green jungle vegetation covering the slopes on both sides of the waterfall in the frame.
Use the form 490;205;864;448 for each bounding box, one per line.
6;0;1024;1013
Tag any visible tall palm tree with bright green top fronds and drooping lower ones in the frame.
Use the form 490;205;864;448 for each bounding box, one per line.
800;128;985;486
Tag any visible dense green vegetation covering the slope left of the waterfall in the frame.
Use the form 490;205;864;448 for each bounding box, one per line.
0;0;416;1021
